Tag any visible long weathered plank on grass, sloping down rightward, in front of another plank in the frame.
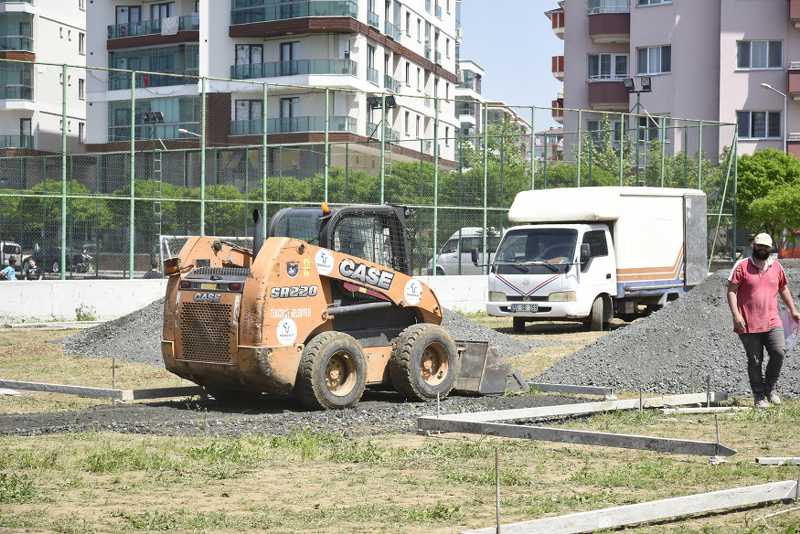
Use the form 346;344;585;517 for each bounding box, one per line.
417;418;736;456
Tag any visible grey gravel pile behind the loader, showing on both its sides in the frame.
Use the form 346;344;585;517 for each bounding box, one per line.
64;299;547;367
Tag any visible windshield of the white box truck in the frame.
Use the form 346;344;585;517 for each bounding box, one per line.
494;228;578;274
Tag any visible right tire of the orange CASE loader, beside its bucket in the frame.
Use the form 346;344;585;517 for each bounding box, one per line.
389;323;461;402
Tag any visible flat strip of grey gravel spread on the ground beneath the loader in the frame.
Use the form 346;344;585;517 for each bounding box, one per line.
0;391;581;436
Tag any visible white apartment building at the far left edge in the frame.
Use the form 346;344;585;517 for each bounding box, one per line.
0;0;87;156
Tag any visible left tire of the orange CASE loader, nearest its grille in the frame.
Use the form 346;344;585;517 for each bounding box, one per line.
295;332;367;410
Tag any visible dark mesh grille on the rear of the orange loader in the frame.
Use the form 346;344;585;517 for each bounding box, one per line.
178;302;232;363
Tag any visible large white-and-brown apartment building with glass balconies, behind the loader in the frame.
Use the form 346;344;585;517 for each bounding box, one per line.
88;0;458;168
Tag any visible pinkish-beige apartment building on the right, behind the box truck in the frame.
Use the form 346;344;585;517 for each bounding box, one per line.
545;0;800;158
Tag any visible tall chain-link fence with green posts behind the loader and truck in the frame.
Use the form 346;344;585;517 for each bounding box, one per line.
0;60;736;278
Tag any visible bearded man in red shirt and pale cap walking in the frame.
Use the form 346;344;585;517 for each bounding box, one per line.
728;234;800;408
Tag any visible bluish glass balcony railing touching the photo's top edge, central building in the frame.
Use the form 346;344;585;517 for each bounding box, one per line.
231;0;358;24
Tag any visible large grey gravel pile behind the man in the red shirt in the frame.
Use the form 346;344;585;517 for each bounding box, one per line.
537;261;800;398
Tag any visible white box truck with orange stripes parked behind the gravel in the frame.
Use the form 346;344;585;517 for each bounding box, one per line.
486;187;708;332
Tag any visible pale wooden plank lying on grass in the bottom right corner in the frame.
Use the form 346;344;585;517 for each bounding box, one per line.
465;480;797;534
